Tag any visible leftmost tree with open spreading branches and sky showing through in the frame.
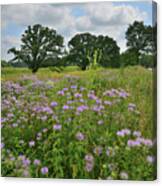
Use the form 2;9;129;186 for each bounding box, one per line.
8;24;63;73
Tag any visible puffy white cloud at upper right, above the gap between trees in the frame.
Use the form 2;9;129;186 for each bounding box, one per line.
86;2;146;26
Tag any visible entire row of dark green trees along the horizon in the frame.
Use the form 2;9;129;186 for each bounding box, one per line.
1;21;157;73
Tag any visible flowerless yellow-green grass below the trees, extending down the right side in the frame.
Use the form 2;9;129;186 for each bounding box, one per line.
2;66;154;137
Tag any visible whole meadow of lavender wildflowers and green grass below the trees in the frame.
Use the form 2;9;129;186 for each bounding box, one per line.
1;67;156;180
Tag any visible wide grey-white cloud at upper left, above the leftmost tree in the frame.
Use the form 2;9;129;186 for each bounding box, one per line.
2;4;71;26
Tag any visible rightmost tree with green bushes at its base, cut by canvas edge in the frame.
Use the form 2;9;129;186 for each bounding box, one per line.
123;21;157;67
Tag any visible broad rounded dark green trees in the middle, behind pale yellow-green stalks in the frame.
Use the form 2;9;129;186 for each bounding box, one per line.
68;33;119;70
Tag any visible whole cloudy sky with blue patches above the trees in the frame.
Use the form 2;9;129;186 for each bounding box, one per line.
1;0;155;60
